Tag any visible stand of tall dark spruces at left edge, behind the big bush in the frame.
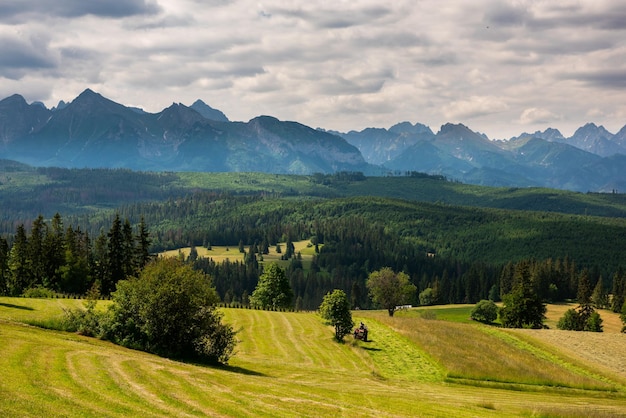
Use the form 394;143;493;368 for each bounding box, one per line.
0;213;150;296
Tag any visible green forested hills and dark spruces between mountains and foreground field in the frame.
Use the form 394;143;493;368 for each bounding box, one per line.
0;167;626;309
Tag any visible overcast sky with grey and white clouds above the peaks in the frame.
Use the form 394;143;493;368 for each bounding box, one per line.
0;0;626;139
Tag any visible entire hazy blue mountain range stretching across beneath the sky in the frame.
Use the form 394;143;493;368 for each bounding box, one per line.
0;89;626;192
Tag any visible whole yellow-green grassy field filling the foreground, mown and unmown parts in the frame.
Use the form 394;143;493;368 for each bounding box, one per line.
0;297;626;417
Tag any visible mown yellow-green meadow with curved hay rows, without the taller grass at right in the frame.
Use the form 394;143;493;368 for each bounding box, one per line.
0;300;626;417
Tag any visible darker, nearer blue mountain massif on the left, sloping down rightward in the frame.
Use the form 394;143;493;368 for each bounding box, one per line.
0;89;372;173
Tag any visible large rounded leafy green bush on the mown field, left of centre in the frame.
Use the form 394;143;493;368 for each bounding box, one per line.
63;258;236;364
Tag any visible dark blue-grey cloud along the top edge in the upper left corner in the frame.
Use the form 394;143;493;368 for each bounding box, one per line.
0;0;160;21
